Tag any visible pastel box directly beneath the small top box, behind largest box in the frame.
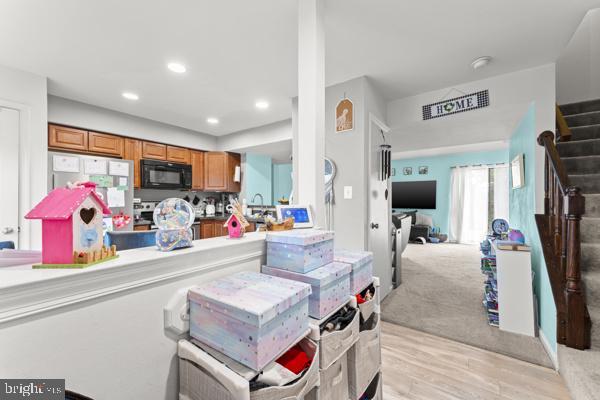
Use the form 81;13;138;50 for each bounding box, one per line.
262;262;352;319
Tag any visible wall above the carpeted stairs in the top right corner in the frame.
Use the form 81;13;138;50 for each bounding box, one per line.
556;9;600;104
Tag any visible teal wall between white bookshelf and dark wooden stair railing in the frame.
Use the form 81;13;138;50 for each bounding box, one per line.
509;104;556;351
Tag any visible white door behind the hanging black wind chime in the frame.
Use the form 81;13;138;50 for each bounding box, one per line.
367;115;392;300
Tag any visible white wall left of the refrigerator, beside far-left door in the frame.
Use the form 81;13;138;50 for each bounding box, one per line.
0;66;48;249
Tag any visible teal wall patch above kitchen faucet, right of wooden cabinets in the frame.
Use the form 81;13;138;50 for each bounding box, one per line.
244;153;273;205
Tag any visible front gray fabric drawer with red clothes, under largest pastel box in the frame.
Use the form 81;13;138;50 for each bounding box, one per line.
178;338;319;400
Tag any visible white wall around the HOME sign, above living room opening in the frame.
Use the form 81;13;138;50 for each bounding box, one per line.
387;64;555;152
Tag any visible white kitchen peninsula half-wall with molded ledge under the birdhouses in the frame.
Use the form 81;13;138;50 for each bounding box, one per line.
0;232;265;399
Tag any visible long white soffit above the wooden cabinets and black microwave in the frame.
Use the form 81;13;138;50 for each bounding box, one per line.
48;96;217;150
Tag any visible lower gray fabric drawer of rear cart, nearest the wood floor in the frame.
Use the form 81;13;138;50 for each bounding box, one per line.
348;313;381;400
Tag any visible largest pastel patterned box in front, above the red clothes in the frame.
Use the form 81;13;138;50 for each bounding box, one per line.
188;272;311;371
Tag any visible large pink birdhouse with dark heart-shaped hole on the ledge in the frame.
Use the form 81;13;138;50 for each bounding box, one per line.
25;182;110;264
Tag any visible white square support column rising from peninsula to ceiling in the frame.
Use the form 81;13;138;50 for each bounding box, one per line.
293;0;325;227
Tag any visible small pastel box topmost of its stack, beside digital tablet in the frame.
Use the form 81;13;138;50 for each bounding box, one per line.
267;229;333;274
